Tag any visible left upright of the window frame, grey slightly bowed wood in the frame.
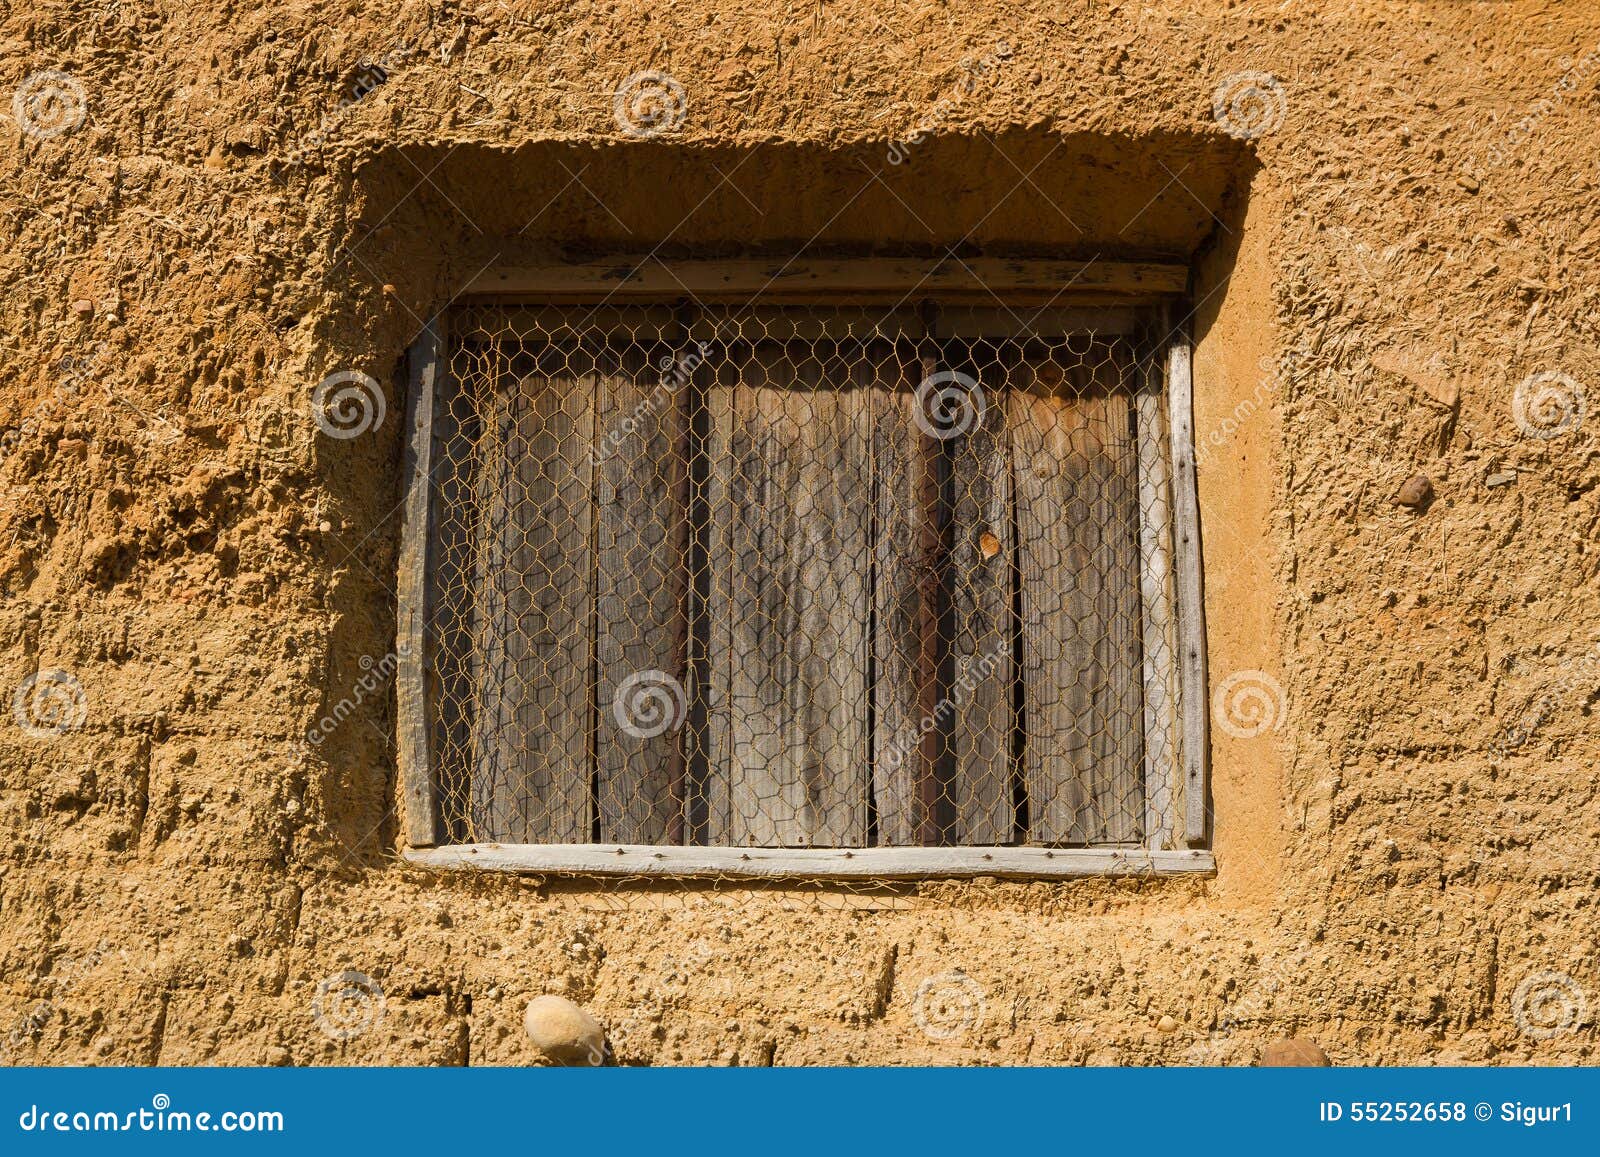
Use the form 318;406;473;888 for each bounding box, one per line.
395;318;443;848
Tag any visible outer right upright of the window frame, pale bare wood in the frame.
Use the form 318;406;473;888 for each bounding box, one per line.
1166;325;1210;845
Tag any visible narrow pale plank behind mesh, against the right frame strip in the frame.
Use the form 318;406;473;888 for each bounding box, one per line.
1136;362;1179;848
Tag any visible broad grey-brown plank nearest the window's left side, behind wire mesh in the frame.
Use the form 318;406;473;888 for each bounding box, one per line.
472;347;595;843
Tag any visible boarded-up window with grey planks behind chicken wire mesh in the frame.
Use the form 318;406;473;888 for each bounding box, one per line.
400;262;1210;874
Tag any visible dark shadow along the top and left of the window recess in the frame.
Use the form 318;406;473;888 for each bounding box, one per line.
307;130;1256;864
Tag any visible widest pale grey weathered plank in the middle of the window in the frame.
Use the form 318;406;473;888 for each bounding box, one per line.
707;344;870;847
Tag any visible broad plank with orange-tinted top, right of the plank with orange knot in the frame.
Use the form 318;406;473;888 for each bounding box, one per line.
1006;344;1142;843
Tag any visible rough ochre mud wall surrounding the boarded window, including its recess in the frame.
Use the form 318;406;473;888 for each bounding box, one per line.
0;0;1600;1064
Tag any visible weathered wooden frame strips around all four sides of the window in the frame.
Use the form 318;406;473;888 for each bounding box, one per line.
395;258;1214;880
